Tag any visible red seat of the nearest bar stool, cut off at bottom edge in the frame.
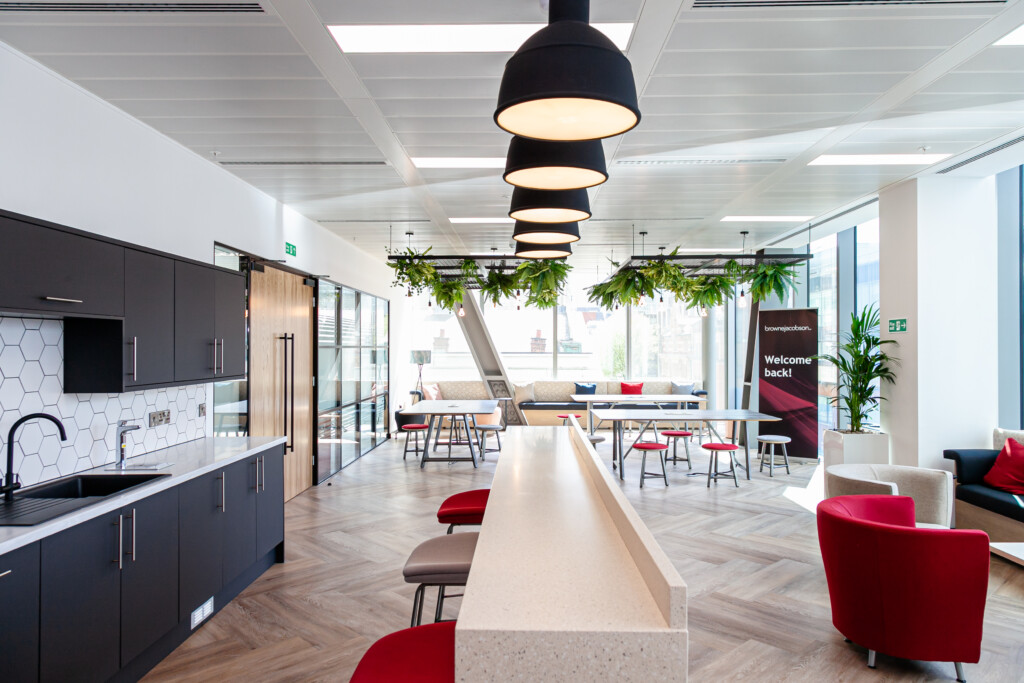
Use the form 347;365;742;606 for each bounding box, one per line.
351;622;455;683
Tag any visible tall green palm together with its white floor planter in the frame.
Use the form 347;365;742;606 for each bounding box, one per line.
816;305;897;467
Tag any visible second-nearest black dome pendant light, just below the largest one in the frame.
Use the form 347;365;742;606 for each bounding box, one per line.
504;135;608;189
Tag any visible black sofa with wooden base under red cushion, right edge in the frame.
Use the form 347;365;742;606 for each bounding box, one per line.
942;449;1024;542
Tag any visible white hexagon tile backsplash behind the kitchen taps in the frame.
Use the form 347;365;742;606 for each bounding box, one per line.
0;317;212;486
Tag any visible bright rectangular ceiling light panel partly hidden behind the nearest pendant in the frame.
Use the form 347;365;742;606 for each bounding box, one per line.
328;24;633;54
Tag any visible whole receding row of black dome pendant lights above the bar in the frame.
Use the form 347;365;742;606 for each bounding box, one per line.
495;0;640;258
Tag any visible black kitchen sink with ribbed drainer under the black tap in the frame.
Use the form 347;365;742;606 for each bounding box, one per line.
0;473;168;526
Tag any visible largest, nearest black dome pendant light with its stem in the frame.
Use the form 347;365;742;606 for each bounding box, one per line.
495;0;640;140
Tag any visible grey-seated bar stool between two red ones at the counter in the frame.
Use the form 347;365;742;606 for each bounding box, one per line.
401;531;480;626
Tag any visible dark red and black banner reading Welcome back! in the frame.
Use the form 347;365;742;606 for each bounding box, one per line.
758;308;818;459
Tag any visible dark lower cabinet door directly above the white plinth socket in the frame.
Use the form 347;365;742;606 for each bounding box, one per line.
178;471;226;621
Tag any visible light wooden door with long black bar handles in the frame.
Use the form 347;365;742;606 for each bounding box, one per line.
249;267;313;501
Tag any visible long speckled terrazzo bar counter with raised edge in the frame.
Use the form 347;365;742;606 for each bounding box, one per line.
456;420;688;683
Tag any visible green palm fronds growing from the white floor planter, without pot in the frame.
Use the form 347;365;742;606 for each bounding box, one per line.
815;305;898;432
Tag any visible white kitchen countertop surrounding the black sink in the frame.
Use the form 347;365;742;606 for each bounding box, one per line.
0;436;286;555
